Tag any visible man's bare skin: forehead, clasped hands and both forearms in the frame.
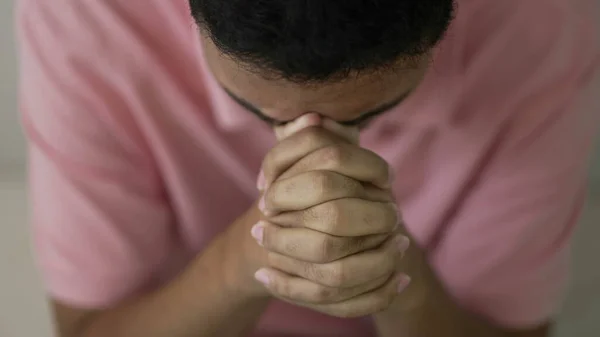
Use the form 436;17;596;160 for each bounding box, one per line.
53;40;549;337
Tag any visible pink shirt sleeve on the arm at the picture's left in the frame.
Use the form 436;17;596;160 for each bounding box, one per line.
17;0;172;308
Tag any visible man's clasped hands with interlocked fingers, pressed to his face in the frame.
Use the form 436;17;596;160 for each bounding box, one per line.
251;114;410;317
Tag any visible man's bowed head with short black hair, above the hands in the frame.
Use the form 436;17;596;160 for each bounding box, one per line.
190;0;453;124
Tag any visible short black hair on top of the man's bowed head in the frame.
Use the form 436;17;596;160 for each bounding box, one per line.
189;0;454;82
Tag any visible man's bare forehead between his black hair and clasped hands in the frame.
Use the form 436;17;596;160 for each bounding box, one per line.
204;38;429;120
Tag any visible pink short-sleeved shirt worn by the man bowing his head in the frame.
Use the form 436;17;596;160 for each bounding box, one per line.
17;0;600;337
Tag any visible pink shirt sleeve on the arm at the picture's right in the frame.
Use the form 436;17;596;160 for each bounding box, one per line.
431;0;600;328
